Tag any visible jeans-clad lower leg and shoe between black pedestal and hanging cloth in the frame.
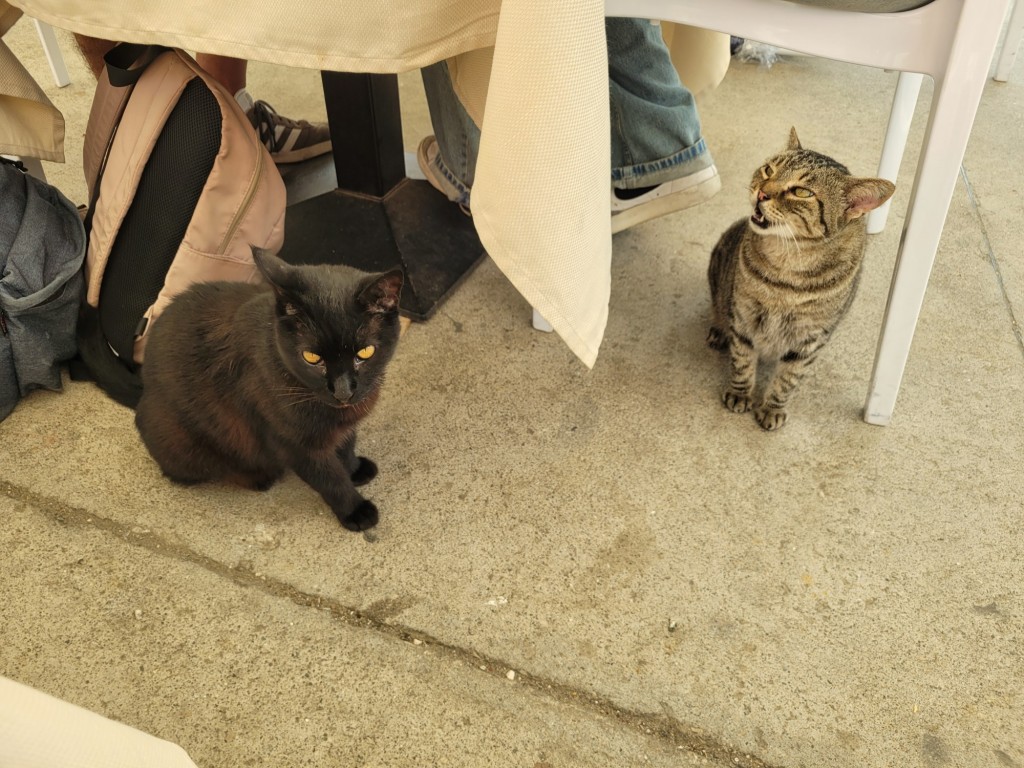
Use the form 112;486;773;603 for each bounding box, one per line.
417;61;480;206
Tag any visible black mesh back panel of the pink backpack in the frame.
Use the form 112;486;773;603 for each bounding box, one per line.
99;78;221;362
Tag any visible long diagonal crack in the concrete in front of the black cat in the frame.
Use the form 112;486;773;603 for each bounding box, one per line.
0;481;779;768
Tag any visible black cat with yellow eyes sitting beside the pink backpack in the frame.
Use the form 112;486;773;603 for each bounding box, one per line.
135;248;402;530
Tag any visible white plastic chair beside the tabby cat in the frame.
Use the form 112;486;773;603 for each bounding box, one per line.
605;0;1010;425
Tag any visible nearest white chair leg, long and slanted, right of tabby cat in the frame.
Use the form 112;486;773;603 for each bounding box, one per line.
864;9;999;425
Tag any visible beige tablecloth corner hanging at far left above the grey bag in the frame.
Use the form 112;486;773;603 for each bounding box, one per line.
0;0;65;163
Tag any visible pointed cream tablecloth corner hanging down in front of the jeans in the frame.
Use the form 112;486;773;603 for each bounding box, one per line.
473;0;611;366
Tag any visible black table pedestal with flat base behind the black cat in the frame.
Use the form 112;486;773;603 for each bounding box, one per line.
281;72;484;321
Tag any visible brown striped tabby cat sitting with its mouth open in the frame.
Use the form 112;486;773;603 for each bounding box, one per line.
708;128;895;430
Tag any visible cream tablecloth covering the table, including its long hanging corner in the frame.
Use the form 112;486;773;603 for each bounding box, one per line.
8;0;728;366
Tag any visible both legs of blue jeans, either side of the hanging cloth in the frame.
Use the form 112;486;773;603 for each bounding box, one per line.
422;18;714;205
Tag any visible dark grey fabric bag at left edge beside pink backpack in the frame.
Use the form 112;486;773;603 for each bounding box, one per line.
0;158;85;420
